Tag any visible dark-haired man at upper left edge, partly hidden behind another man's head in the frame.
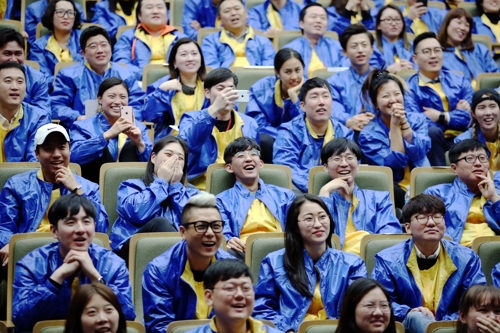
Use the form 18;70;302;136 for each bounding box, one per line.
0;28;52;111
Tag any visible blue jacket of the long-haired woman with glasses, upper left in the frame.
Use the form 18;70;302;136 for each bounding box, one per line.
29;29;83;86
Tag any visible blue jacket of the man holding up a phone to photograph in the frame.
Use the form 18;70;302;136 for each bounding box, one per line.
179;108;259;180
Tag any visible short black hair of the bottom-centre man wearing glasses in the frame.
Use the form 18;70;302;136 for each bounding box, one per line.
203;259;253;290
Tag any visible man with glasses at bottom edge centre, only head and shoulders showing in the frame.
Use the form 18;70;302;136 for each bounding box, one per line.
188;259;281;333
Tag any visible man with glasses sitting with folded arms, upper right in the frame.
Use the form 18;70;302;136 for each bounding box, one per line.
407;32;474;166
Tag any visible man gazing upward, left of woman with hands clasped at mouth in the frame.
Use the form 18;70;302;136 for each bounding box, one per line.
273;78;353;194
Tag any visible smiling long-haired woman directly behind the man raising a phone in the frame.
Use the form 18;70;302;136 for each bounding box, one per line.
143;38;210;142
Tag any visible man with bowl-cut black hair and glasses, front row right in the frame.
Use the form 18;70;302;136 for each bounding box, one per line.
372;194;486;333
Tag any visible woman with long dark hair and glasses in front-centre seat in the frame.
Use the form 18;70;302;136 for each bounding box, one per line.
253;194;366;332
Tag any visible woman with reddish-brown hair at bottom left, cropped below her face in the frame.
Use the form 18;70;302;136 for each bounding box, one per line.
64;283;127;333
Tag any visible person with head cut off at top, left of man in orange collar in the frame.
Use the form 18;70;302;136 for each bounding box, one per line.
91;0;139;42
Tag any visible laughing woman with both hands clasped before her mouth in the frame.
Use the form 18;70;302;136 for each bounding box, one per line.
359;69;431;208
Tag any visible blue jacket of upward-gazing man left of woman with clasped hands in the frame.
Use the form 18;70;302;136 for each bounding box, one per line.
273;116;354;193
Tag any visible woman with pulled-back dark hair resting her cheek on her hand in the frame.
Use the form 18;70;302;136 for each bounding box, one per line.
245;48;305;163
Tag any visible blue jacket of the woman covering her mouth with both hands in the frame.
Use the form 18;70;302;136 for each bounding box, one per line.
110;177;199;250
